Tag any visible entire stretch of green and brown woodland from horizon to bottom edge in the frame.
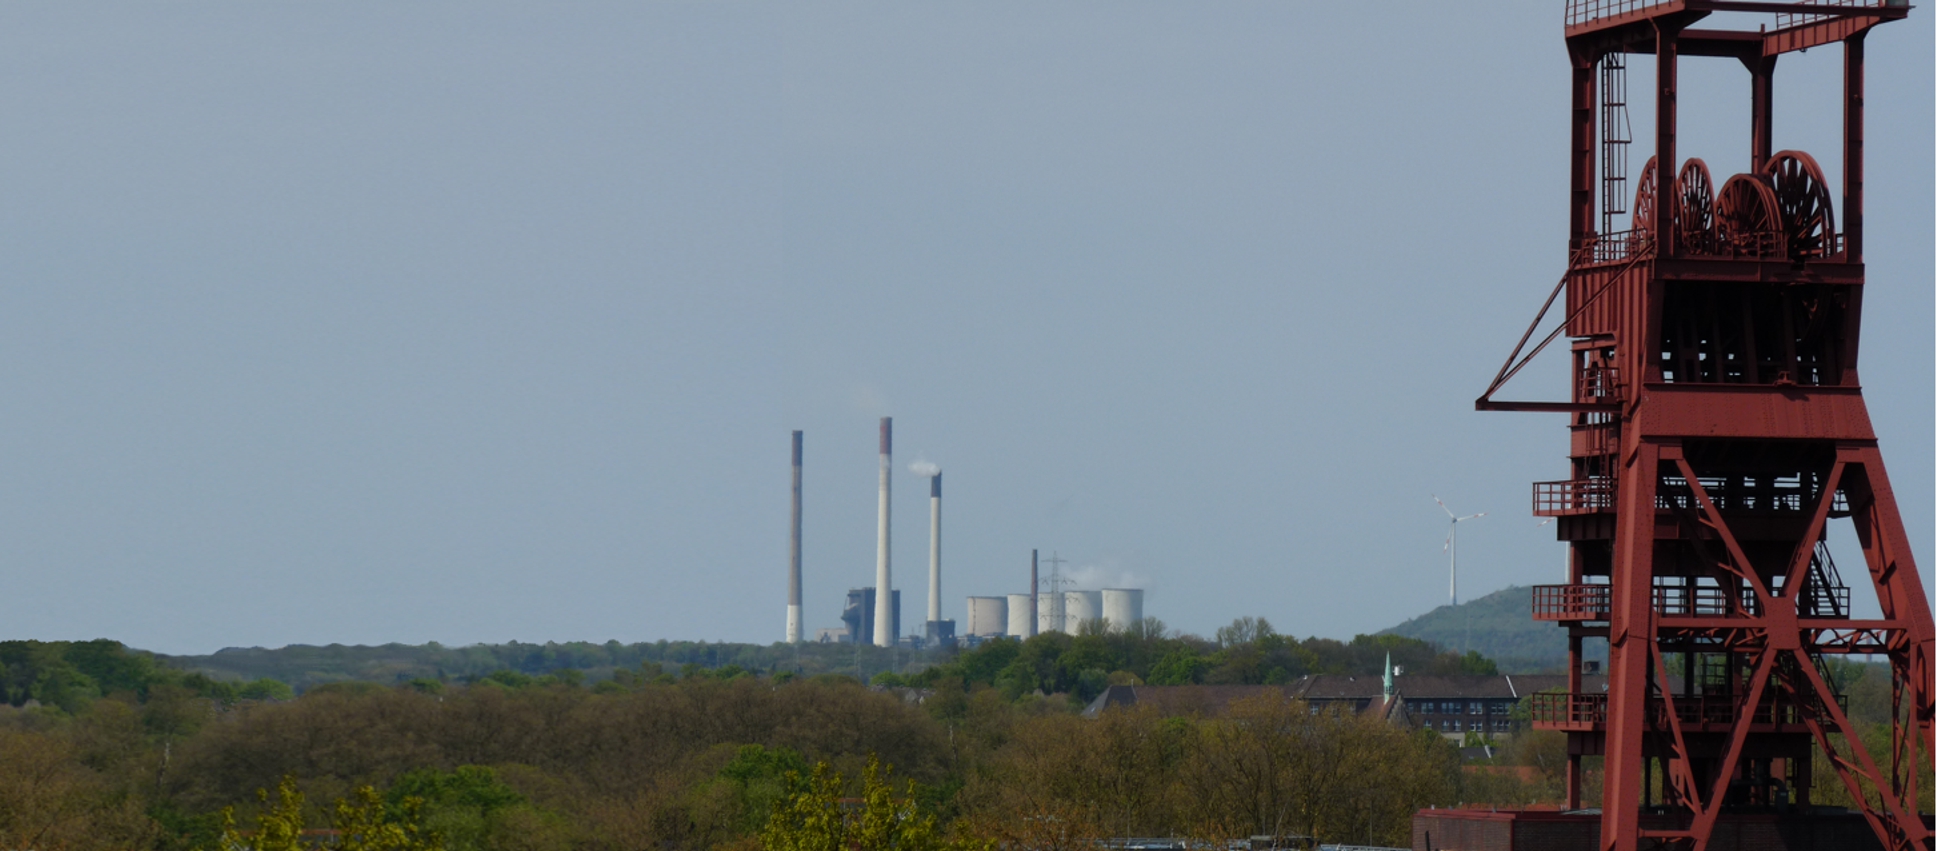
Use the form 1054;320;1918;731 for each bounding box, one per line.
0;620;1889;851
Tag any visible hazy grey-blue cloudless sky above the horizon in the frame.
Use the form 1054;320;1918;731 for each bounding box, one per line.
0;0;1937;653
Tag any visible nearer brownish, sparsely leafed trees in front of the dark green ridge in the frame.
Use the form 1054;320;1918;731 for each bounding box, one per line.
0;662;1460;851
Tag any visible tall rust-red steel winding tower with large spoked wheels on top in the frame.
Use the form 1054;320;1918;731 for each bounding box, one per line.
1476;0;1933;851
